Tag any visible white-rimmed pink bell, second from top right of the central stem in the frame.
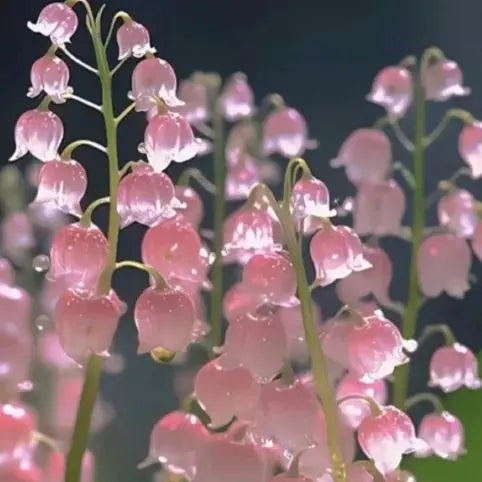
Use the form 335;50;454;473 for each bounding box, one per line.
310;225;371;286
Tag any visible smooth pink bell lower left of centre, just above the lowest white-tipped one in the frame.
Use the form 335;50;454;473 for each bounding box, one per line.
194;360;260;427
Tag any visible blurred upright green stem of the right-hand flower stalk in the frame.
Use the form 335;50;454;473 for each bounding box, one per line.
393;72;425;408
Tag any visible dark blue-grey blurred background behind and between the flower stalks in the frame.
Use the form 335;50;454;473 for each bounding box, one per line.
0;0;482;482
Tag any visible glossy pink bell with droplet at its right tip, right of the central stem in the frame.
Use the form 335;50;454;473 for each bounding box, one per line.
347;314;417;382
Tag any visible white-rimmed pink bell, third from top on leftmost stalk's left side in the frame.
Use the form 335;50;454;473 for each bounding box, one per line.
10;109;64;162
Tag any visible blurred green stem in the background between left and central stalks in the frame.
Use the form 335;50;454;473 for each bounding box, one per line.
210;99;226;347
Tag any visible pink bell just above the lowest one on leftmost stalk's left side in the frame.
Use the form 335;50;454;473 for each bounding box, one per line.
48;223;108;293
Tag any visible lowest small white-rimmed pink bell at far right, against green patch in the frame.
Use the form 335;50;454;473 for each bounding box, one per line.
415;411;466;460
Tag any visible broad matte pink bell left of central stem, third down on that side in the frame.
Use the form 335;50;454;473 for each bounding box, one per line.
219;312;288;383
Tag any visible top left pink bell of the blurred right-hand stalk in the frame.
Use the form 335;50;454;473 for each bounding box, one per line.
367;66;412;117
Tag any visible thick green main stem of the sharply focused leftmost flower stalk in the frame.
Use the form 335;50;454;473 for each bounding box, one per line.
65;8;120;482
